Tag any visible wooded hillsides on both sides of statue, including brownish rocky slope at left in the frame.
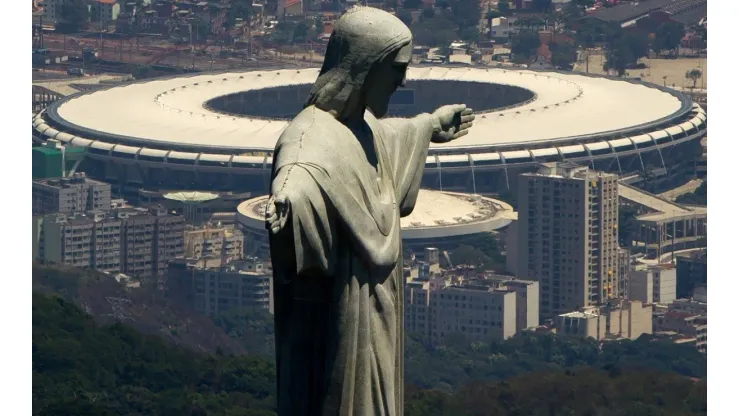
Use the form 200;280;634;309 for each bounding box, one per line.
33;264;706;416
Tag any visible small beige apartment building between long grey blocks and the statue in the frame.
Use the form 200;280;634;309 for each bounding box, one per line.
185;226;244;262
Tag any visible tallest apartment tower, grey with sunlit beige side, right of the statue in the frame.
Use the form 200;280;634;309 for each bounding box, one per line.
516;163;626;318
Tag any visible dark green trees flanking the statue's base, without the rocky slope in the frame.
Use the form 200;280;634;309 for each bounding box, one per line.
33;294;706;416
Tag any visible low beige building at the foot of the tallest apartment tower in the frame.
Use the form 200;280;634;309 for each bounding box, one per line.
555;300;653;340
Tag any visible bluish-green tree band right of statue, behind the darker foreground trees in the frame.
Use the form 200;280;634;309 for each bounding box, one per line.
405;333;707;391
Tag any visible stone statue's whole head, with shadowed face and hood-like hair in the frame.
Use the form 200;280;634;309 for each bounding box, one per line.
306;7;412;118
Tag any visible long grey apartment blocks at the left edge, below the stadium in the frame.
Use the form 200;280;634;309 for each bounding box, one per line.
33;208;184;280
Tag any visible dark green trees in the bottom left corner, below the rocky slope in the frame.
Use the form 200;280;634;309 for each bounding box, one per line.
32;294;275;416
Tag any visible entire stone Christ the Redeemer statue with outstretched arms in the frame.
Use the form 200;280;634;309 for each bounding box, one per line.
266;7;474;416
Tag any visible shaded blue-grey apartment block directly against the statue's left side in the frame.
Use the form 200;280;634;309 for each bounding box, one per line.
167;259;273;316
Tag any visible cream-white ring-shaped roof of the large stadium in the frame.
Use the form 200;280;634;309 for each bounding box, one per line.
44;67;682;151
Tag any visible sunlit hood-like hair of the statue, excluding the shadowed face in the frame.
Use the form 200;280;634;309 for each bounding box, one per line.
305;6;411;118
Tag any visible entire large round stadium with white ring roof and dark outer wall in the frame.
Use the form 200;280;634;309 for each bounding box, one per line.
33;66;707;195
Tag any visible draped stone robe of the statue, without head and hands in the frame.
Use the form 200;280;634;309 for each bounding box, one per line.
270;106;433;416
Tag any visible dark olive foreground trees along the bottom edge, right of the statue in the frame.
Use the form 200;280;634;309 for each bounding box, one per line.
405;368;707;416
